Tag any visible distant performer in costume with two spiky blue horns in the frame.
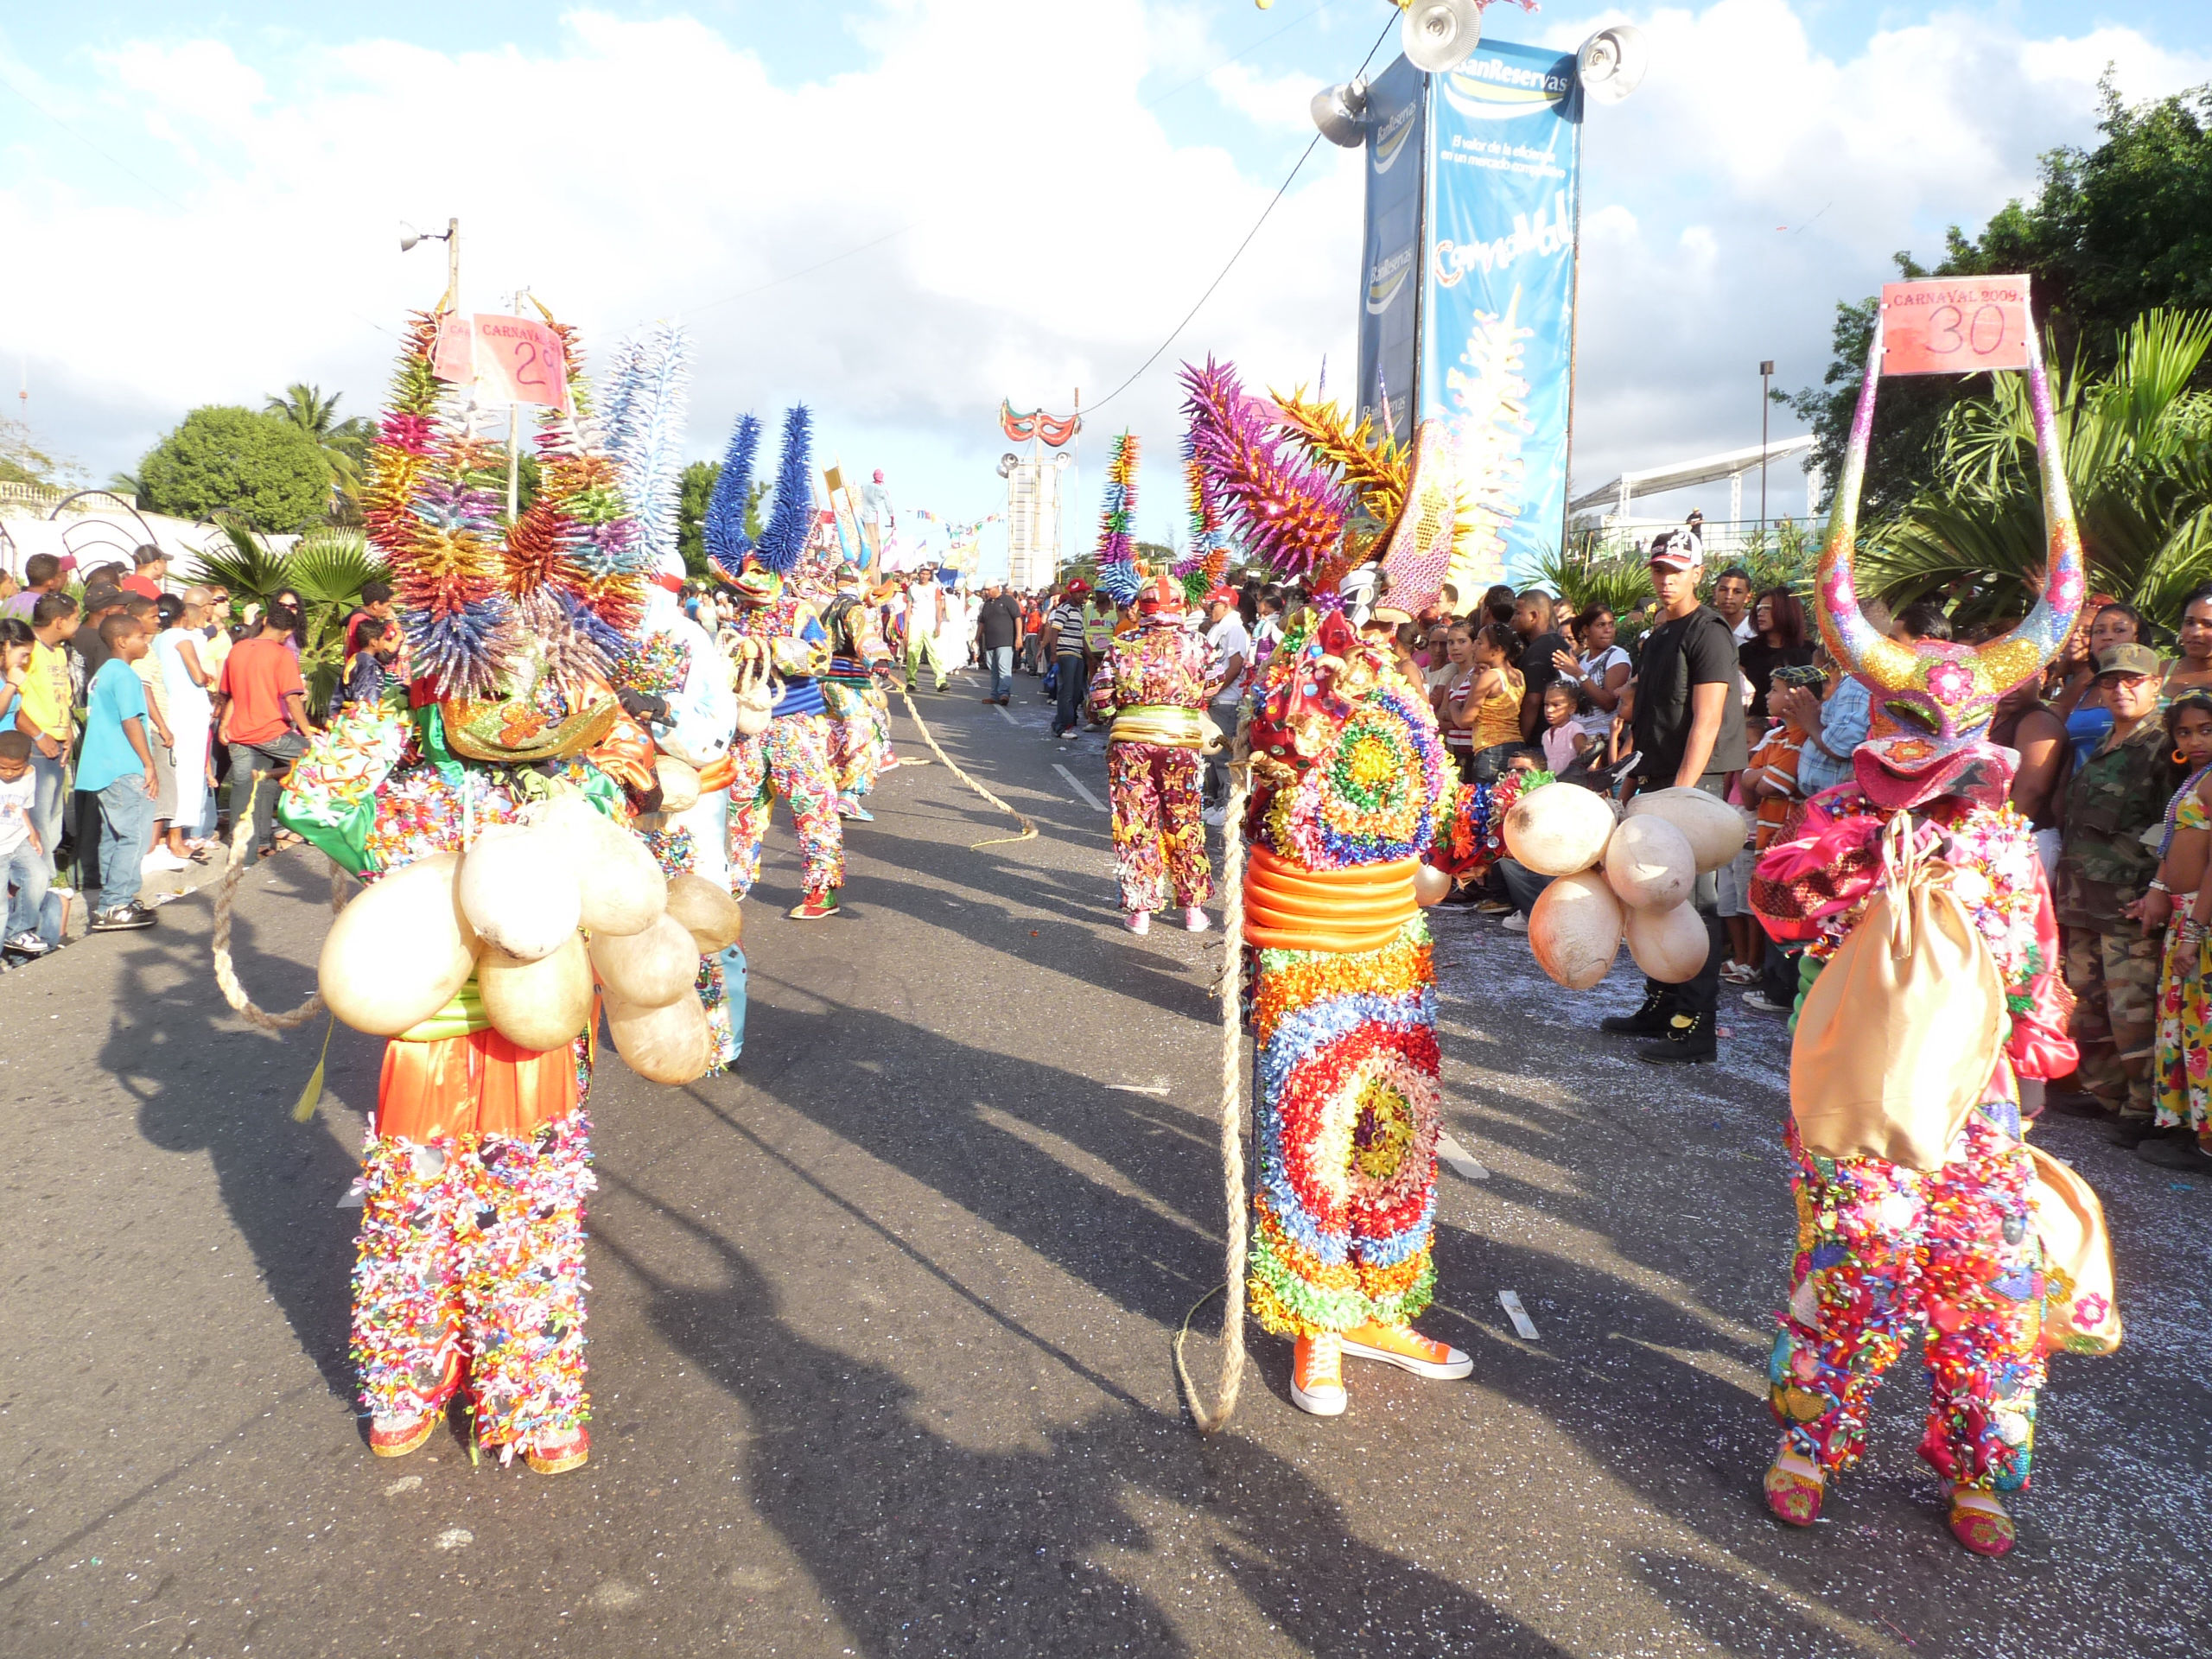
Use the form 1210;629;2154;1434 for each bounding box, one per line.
708;407;845;920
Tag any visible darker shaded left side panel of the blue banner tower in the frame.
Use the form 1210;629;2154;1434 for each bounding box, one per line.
1358;58;1429;442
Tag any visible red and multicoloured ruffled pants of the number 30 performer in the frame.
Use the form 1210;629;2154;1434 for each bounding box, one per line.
1767;1109;2044;1491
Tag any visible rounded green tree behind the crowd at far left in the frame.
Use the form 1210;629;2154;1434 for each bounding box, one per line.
139;404;329;536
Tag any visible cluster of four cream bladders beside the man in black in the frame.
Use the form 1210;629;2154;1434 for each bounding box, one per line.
1504;783;1745;991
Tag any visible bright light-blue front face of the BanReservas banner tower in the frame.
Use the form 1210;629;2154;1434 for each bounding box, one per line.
1424;40;1581;595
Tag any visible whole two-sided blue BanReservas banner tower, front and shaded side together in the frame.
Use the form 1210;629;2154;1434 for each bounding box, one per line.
1358;40;1581;586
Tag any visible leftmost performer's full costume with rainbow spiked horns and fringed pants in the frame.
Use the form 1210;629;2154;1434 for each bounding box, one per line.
279;309;685;1473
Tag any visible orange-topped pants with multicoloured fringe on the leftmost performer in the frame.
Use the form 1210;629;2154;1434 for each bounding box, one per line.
352;1028;597;1453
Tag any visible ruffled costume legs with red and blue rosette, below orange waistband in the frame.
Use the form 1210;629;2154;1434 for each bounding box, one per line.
1245;916;1442;1336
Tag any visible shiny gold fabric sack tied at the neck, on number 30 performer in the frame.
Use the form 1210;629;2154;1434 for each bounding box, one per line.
1789;812;2006;1170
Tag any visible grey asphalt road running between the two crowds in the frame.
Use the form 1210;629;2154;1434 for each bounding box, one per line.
0;679;2212;1659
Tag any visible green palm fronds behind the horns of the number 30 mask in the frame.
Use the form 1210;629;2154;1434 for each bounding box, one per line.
1860;309;2212;628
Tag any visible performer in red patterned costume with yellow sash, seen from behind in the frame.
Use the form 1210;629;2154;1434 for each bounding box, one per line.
1090;575;1212;933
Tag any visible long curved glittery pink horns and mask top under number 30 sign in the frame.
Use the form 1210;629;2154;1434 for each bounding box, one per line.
1816;315;2084;752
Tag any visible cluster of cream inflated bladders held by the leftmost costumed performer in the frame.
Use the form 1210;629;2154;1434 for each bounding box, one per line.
319;797;741;1084
